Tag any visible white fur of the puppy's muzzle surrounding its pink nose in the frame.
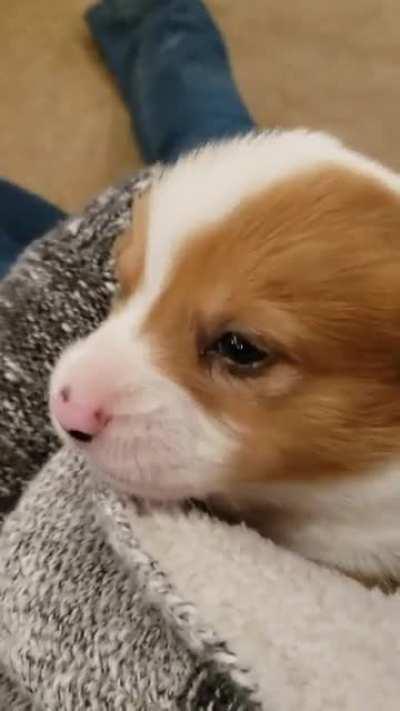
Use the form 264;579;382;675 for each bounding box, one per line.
50;308;235;500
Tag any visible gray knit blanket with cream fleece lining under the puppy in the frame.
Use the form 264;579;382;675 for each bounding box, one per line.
0;174;400;711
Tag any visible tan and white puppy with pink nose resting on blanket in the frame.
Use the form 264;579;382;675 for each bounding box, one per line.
50;130;400;583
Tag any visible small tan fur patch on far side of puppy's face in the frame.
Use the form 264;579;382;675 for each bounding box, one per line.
114;188;151;305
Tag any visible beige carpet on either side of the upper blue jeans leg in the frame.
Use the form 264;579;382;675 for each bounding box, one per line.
0;0;400;210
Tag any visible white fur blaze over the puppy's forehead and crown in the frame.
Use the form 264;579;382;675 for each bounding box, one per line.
138;129;400;306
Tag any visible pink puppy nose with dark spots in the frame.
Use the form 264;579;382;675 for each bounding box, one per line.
52;387;111;442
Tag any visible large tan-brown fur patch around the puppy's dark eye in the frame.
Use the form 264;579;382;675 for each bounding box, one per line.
124;166;400;490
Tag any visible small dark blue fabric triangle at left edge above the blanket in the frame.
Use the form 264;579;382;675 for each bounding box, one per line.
0;178;65;278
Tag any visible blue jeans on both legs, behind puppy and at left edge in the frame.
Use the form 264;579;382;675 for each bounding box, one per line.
0;0;254;276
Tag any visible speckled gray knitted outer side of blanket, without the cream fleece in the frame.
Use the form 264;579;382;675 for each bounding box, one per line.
0;174;258;711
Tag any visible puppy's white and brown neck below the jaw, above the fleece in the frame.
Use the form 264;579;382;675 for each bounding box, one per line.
215;464;400;588
